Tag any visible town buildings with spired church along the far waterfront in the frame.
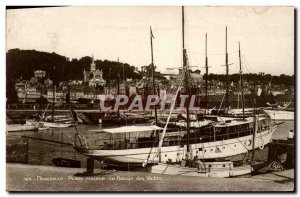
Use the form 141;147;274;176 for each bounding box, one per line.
15;53;294;107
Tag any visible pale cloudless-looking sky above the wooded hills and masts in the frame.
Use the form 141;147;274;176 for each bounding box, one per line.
7;7;294;75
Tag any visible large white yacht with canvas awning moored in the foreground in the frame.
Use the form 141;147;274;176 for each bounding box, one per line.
73;7;277;171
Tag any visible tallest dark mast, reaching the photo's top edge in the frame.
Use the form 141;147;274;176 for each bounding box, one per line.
182;6;191;157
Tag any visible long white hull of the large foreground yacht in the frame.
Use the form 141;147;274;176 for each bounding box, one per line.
74;125;277;166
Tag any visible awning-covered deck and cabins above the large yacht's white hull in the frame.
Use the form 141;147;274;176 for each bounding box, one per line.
88;117;271;150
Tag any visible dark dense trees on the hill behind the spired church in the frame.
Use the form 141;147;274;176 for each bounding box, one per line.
6;49;141;81
